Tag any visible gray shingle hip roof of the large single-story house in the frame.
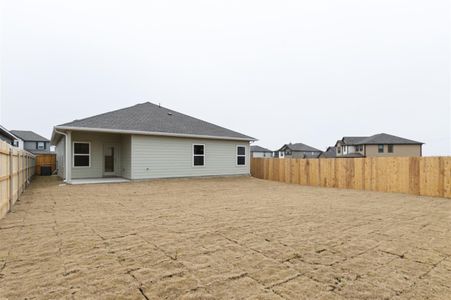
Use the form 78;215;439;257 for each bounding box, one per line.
57;102;255;140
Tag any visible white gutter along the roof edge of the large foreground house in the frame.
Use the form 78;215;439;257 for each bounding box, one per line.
52;126;257;141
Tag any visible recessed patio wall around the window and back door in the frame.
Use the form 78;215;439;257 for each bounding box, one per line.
71;131;127;179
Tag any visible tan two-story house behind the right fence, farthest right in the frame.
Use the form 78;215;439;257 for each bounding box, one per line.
335;133;423;157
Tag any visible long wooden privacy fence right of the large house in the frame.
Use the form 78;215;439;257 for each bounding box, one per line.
251;157;451;198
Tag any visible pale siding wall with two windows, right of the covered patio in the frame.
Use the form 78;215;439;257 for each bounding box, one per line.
131;135;250;179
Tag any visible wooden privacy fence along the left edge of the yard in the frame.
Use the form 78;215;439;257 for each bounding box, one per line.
0;141;35;219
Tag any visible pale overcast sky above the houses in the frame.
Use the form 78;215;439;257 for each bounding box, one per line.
0;0;451;155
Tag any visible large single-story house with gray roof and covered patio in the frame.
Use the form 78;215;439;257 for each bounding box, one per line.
51;102;255;183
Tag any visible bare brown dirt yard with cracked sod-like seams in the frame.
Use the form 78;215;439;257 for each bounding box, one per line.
0;178;451;299
